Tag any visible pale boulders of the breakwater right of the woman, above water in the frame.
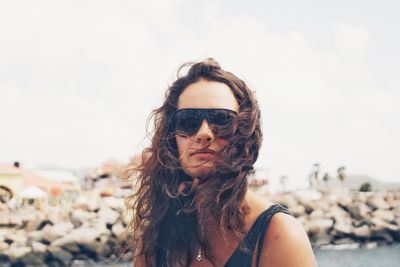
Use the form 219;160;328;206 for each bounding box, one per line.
272;191;400;248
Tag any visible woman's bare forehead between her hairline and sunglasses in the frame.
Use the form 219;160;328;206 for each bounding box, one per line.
177;80;239;112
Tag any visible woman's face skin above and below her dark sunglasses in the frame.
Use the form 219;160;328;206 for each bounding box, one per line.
176;80;239;178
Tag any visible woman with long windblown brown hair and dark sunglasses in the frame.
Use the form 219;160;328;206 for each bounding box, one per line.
129;59;316;267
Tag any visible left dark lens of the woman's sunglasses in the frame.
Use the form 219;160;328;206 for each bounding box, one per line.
174;110;202;135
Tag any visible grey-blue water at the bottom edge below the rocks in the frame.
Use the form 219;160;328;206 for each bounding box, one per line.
90;244;400;267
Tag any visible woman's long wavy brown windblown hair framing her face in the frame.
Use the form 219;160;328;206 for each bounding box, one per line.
126;58;262;266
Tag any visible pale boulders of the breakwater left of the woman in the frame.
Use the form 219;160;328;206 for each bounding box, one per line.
0;192;129;266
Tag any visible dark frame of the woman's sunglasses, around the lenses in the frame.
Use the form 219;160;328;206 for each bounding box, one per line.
169;108;238;136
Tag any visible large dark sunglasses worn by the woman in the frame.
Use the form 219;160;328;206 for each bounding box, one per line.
170;108;237;136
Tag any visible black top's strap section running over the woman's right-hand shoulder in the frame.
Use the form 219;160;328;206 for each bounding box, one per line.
225;204;291;267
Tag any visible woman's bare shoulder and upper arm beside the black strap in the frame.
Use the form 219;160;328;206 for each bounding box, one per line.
260;213;317;267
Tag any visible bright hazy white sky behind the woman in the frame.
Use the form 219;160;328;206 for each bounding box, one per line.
0;0;400;188
